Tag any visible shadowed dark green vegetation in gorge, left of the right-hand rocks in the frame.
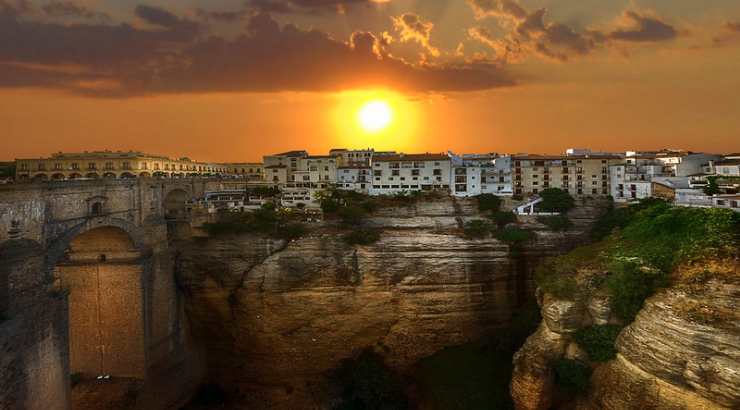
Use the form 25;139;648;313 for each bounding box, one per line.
414;301;542;410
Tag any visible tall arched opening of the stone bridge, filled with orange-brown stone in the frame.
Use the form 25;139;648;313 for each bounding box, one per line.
54;226;146;379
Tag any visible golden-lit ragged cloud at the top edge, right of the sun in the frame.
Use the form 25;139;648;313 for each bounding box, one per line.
468;0;678;62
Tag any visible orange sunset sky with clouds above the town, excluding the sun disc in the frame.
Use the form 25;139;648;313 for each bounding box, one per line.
0;0;740;162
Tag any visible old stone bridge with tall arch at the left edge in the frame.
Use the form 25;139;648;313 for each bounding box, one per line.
0;179;206;410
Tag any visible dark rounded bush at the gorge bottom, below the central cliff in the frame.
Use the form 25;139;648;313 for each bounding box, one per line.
333;349;411;410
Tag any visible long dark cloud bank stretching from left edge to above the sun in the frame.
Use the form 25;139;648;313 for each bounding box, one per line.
0;7;514;97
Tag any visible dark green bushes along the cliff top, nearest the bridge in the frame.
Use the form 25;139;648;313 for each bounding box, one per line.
203;202;308;240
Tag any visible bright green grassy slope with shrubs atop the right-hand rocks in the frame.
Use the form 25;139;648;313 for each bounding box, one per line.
535;198;740;321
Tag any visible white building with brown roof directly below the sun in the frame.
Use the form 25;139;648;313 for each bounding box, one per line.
370;154;452;195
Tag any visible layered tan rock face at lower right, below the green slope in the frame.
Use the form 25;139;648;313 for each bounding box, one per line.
511;259;740;410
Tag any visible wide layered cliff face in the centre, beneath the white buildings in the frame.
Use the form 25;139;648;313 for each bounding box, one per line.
176;199;599;409
